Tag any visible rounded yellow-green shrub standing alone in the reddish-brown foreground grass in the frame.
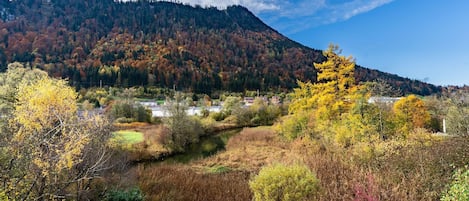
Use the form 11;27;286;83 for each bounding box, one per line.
249;164;319;201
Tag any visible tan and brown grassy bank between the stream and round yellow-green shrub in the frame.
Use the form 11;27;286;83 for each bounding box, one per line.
125;127;282;201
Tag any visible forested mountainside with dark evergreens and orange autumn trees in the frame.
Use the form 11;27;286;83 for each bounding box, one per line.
0;0;440;95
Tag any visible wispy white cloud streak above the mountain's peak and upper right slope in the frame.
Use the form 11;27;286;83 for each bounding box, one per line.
121;0;394;33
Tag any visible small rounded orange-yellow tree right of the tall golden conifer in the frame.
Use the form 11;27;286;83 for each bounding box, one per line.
393;95;430;136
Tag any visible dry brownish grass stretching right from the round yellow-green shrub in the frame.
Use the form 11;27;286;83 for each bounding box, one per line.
293;138;469;200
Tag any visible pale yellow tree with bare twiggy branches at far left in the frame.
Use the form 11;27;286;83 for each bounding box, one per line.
3;77;109;200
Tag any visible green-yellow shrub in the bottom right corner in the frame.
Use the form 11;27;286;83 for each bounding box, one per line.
441;166;469;201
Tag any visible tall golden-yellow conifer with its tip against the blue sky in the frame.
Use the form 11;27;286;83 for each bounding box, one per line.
289;44;356;116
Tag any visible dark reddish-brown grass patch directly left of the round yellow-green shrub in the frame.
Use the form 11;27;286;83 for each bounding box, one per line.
137;165;252;201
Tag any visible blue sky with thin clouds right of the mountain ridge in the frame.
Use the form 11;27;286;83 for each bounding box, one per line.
158;0;469;86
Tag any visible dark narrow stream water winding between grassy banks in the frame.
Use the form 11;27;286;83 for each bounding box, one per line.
157;129;242;164
